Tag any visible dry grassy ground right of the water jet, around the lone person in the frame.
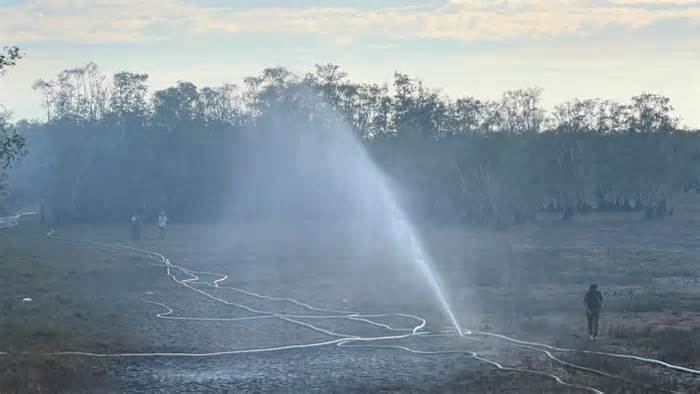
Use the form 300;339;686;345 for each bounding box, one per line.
416;201;700;393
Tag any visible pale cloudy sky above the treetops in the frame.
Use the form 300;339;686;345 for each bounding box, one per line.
0;0;700;128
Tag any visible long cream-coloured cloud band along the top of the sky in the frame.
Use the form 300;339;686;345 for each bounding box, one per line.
0;0;700;46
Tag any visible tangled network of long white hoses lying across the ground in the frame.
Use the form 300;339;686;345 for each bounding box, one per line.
0;213;700;393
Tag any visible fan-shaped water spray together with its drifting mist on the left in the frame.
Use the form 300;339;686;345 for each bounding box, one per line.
224;95;457;332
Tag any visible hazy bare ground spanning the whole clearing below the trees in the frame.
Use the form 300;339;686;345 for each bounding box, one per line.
0;200;700;393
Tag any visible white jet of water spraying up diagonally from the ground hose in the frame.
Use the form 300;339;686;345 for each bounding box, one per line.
235;101;462;334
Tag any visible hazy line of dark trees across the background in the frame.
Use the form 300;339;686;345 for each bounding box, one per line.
5;63;700;225
